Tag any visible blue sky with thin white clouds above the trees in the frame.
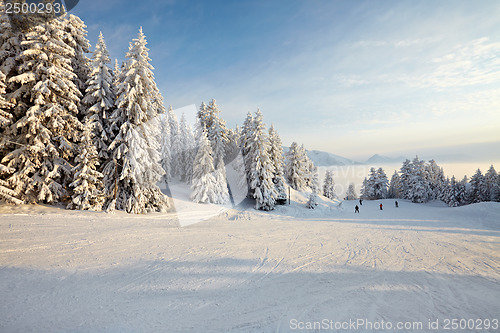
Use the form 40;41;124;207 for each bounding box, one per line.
72;0;500;161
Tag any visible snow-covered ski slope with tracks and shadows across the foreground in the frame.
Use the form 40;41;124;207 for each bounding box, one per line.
0;193;500;332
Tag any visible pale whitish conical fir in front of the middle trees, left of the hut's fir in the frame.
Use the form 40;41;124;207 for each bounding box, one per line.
191;124;217;203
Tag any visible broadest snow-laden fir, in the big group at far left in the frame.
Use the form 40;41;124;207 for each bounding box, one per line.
3;14;82;203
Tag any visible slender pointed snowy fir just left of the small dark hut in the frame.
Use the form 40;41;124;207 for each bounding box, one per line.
248;110;278;211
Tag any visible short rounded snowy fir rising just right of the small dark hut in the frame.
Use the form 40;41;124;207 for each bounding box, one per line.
285;142;310;191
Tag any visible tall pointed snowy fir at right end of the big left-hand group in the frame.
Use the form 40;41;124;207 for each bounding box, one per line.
104;28;168;214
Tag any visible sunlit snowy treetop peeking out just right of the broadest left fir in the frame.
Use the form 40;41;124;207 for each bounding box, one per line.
64;14;91;95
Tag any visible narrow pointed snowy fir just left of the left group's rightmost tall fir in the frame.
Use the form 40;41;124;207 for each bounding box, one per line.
81;33;115;164
